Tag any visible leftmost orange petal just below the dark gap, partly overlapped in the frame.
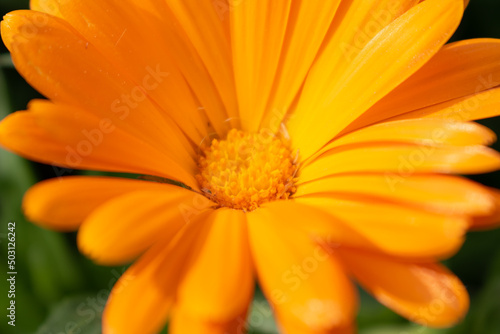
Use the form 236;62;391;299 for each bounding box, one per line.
23;176;188;231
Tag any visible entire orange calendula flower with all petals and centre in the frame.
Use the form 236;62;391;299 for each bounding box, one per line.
0;0;500;334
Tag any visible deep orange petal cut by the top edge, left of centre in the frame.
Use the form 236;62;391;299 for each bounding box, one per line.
32;0;217;143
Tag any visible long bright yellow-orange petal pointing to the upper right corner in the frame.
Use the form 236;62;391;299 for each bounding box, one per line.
288;0;463;158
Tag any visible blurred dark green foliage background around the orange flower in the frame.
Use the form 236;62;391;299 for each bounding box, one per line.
0;0;500;334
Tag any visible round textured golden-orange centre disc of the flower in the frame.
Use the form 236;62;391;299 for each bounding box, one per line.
196;129;298;211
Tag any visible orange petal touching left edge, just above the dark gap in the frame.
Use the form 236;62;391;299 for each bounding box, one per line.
0;101;197;188
